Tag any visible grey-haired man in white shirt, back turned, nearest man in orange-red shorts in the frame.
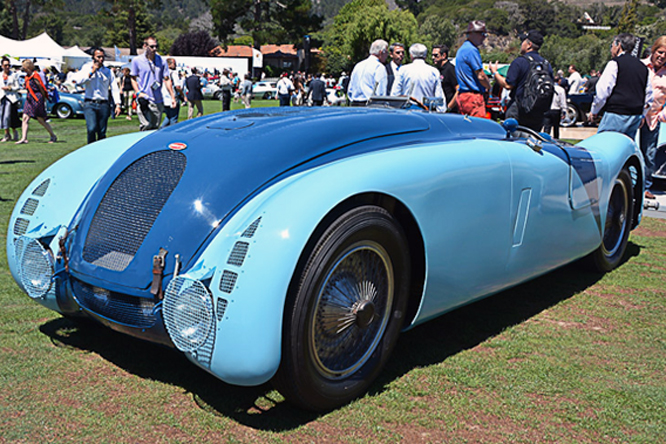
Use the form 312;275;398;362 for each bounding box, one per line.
391;43;446;112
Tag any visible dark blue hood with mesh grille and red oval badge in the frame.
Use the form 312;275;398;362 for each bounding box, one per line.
69;108;431;295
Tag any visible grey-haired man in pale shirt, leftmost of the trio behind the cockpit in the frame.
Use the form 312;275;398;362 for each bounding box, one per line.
349;39;388;106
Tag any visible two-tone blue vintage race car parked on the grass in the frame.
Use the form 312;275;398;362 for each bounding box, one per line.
7;107;643;410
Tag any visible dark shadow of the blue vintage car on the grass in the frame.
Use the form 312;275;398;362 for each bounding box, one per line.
40;242;640;432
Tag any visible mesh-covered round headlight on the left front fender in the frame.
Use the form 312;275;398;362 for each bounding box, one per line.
16;236;54;299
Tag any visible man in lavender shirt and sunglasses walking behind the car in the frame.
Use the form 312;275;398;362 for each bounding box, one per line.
130;37;178;131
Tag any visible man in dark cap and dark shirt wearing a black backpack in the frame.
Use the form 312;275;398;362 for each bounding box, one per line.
490;29;555;131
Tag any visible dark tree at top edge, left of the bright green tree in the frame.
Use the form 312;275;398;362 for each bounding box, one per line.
210;0;322;48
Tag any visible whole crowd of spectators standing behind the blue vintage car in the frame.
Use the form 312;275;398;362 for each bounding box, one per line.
0;26;666;198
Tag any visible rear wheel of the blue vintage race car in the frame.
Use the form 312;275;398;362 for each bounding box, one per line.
590;169;634;273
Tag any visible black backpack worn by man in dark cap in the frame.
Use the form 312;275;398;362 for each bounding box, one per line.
516;55;555;113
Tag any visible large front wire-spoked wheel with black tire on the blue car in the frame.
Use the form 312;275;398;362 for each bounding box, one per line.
273;206;410;411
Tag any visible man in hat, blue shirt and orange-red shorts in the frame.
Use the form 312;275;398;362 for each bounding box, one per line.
456;20;490;117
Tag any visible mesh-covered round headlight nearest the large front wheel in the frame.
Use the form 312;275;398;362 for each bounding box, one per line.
162;276;213;352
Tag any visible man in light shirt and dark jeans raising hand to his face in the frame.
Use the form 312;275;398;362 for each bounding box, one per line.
77;48;121;143
